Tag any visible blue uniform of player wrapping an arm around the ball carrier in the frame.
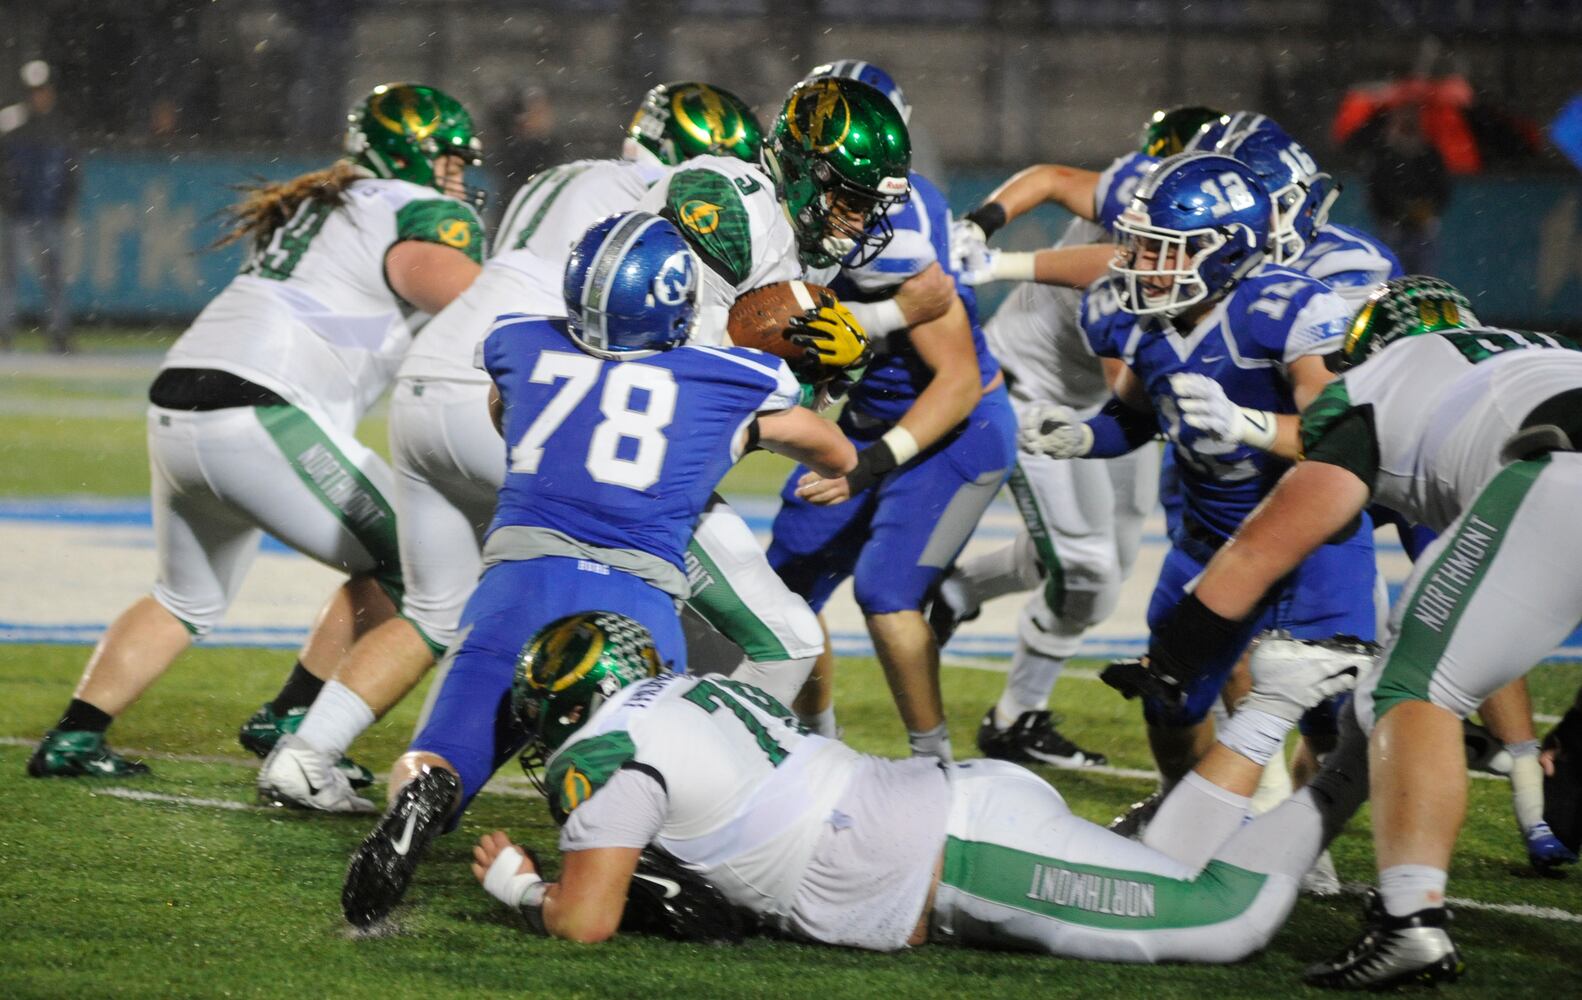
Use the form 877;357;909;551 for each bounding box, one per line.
769;174;1016;614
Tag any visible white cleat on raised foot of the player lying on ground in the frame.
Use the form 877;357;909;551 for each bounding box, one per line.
1237;631;1378;722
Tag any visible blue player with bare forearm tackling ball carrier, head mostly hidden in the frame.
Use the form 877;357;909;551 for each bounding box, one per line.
769;60;1016;759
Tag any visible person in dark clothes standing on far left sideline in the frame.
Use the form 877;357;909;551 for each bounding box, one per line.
0;60;78;354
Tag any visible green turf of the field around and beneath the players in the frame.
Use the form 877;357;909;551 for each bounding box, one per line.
0;332;1582;1000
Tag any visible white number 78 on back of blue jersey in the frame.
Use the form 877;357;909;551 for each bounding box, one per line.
511;351;676;489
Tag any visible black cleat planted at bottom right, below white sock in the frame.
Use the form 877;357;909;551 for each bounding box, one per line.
1302;889;1467;991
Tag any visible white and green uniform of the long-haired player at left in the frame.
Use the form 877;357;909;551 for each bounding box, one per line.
149;179;484;634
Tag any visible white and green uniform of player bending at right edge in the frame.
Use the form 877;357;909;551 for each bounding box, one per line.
1302;328;1582;728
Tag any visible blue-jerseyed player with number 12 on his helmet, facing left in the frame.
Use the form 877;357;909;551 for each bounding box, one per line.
1022;152;1375;829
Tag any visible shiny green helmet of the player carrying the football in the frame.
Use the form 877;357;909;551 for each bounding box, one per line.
764;76;911;267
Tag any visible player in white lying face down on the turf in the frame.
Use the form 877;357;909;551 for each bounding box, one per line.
473;612;1372;962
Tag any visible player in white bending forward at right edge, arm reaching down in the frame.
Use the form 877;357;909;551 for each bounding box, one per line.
1149;275;1582;989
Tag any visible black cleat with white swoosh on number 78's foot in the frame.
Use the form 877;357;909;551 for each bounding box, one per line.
340;767;462;927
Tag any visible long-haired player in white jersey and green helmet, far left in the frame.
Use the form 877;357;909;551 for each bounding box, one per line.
28;84;484;780
